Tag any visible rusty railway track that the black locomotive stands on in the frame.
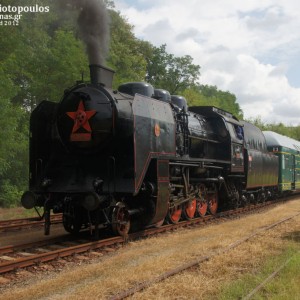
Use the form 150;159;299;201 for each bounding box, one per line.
0;197;296;274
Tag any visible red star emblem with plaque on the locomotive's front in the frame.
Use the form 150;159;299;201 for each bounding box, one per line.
66;100;96;141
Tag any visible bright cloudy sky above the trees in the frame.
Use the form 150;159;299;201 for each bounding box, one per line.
114;0;300;126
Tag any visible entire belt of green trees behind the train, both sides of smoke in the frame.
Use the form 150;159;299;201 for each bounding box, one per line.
0;0;300;206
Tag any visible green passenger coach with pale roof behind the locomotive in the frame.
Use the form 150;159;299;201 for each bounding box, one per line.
263;131;300;193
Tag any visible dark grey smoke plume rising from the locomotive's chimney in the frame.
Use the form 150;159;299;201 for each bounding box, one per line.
62;0;109;64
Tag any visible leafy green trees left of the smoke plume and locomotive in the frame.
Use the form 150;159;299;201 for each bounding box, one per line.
0;0;87;206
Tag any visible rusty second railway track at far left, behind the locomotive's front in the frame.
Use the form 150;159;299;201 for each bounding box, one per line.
0;214;62;232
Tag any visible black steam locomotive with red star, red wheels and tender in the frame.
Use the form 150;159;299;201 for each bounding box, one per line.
21;65;278;235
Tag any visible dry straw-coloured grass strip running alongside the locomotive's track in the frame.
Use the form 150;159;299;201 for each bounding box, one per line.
0;200;300;300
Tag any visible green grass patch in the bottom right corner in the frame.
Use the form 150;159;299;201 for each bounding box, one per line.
218;242;300;300
